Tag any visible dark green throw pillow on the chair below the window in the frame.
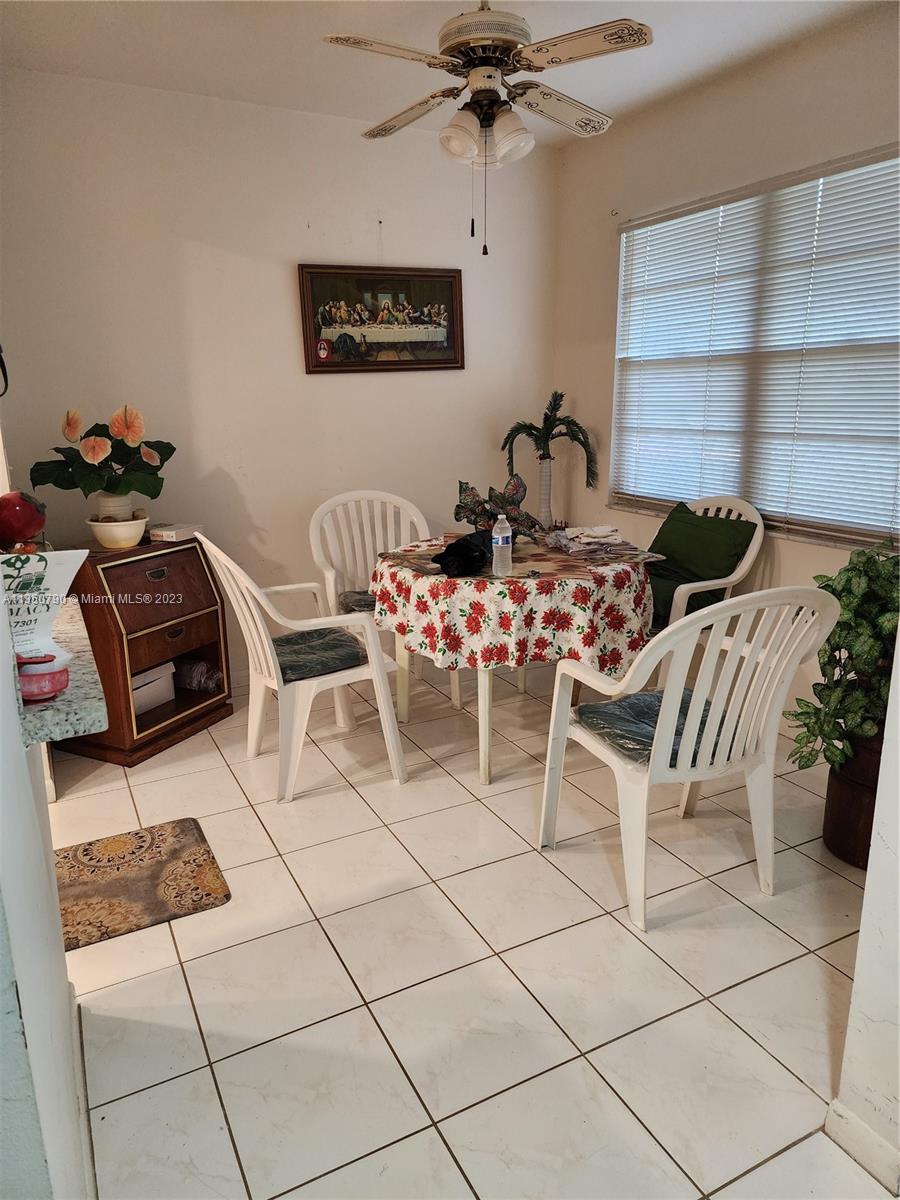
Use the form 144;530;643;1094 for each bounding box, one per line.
647;504;756;628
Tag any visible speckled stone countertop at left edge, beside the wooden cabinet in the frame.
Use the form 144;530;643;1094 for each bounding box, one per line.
19;599;108;745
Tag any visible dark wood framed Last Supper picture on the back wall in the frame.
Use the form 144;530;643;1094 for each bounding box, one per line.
298;263;466;374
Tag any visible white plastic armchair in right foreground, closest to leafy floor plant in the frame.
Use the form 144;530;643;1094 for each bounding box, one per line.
539;587;840;929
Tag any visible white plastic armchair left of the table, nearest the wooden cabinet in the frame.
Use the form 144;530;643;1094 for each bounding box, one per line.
196;533;407;803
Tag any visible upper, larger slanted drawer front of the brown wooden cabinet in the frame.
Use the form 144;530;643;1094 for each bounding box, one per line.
101;545;218;634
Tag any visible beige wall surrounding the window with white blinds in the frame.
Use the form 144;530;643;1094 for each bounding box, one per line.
553;4;898;587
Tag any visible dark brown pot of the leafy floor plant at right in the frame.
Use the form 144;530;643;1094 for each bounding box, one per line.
822;733;883;870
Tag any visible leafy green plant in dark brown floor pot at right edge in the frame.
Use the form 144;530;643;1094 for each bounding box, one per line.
785;542;900;868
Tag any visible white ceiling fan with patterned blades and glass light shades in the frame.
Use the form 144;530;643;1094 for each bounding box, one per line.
325;0;653;169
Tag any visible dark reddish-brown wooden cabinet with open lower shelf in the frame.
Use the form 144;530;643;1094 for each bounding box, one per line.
58;539;232;767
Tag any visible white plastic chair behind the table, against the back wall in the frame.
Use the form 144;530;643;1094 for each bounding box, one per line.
310;491;431;728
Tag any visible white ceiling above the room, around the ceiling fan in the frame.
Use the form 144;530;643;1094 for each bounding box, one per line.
0;0;859;143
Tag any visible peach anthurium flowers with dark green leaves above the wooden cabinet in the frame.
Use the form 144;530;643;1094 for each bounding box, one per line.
31;404;175;500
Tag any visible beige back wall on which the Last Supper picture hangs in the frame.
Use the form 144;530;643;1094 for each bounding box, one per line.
2;71;553;604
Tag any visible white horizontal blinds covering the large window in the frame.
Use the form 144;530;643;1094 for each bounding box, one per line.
611;160;900;534
